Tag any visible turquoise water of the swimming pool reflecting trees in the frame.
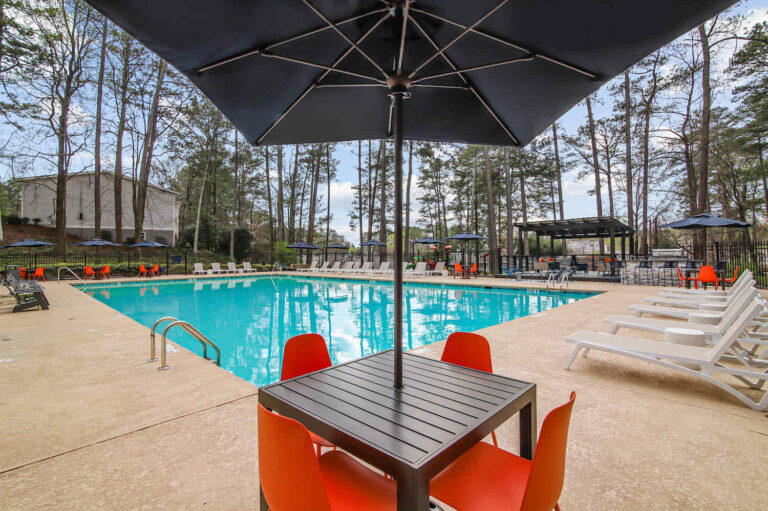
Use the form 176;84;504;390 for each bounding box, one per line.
82;276;591;386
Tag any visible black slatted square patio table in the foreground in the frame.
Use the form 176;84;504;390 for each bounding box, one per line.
259;350;536;511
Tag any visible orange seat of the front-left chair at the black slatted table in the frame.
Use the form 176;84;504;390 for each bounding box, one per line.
319;451;397;511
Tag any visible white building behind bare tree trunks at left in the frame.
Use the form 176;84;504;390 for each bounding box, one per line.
16;172;179;246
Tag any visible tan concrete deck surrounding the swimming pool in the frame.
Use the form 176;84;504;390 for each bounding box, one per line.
0;277;768;510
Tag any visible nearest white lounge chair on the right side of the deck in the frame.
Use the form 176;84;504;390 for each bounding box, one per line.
565;300;768;411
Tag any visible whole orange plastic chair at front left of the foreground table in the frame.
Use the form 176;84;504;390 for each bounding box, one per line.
258;405;397;511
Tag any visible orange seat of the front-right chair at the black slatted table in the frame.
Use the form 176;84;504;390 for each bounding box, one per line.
429;442;533;511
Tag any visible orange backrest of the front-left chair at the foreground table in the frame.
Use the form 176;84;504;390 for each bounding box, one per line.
258;405;331;511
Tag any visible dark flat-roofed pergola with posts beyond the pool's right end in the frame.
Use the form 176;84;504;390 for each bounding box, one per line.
515;216;635;275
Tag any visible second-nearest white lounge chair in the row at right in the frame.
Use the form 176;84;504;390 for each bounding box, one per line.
603;288;761;343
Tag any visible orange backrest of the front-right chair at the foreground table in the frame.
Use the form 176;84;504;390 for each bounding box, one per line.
520;392;576;511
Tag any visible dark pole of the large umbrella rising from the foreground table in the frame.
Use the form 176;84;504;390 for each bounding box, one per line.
391;87;406;389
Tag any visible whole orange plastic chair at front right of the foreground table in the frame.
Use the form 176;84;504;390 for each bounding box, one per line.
430;392;576;511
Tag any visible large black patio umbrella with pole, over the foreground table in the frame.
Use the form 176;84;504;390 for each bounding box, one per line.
88;0;734;388
